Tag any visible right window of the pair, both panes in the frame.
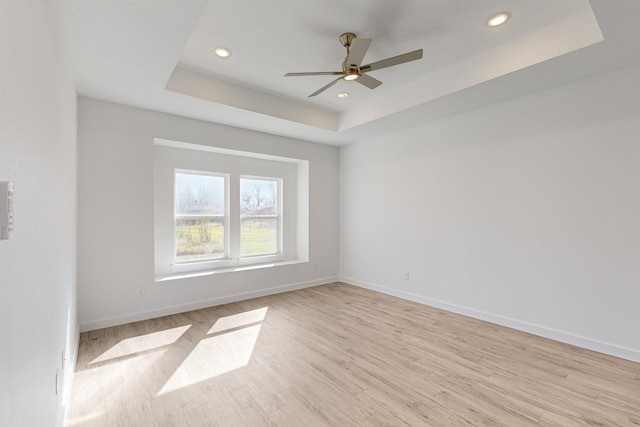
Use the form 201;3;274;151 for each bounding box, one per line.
240;177;281;257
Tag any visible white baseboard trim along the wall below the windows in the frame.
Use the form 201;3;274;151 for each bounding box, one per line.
80;277;338;332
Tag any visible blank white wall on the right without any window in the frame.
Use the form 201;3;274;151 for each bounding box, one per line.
340;66;640;361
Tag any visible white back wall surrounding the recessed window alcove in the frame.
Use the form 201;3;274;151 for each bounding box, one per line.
78;98;338;330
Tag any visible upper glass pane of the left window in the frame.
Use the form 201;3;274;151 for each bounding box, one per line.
175;173;224;215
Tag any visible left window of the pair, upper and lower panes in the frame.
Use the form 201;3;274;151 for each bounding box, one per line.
174;171;228;263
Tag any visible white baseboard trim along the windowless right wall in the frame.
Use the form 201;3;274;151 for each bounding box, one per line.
339;277;640;363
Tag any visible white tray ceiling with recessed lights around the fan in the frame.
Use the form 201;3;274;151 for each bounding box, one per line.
63;0;640;145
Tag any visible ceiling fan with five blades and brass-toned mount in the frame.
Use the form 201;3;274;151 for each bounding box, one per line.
285;33;422;98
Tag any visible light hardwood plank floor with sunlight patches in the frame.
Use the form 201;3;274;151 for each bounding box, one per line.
68;283;640;427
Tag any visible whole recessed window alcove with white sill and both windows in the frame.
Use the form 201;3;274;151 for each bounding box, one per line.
154;139;309;280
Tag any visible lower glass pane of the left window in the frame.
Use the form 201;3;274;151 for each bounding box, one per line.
176;218;224;261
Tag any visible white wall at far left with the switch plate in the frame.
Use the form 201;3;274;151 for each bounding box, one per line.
0;0;78;426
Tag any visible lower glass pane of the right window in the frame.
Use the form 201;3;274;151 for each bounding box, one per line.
240;218;278;256
